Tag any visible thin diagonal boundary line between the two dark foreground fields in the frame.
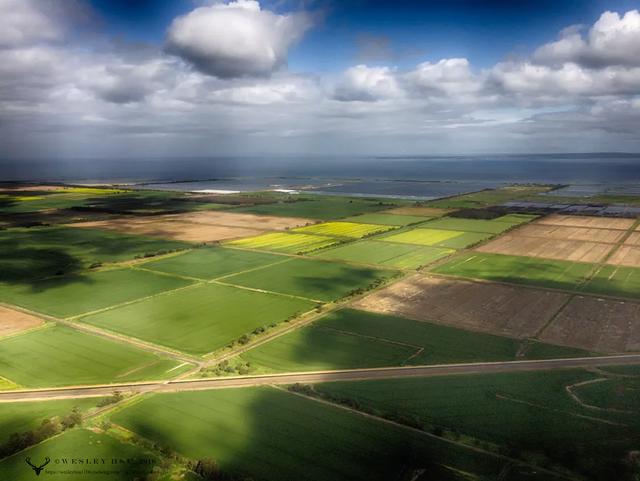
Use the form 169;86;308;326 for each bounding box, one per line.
278;386;580;481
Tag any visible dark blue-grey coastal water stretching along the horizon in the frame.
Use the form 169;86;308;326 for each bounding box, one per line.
0;154;640;198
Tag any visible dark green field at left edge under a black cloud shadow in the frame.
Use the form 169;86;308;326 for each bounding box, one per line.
0;227;188;283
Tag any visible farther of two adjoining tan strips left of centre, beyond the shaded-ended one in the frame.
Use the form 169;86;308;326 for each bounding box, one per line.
163;211;317;230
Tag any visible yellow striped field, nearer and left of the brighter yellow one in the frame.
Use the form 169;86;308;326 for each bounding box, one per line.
228;232;340;254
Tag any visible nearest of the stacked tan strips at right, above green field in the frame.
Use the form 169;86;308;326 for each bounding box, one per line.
476;232;615;263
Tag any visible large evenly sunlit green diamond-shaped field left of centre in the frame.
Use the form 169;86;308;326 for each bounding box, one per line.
81;284;315;354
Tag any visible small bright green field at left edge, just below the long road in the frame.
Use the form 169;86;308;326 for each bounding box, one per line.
0;398;100;444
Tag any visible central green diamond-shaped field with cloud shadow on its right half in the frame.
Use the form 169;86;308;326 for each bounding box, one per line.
224;258;396;302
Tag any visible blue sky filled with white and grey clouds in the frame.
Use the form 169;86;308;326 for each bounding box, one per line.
0;0;640;161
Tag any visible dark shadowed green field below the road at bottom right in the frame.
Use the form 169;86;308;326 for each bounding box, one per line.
315;370;640;480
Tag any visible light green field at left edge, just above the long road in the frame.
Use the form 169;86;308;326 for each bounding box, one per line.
0;326;188;388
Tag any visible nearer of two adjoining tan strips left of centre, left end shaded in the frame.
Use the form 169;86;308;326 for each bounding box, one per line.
68;218;264;242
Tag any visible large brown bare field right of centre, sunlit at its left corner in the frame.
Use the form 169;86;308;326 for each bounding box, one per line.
353;275;569;338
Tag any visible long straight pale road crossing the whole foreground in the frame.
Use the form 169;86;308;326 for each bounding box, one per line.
0;354;640;402
